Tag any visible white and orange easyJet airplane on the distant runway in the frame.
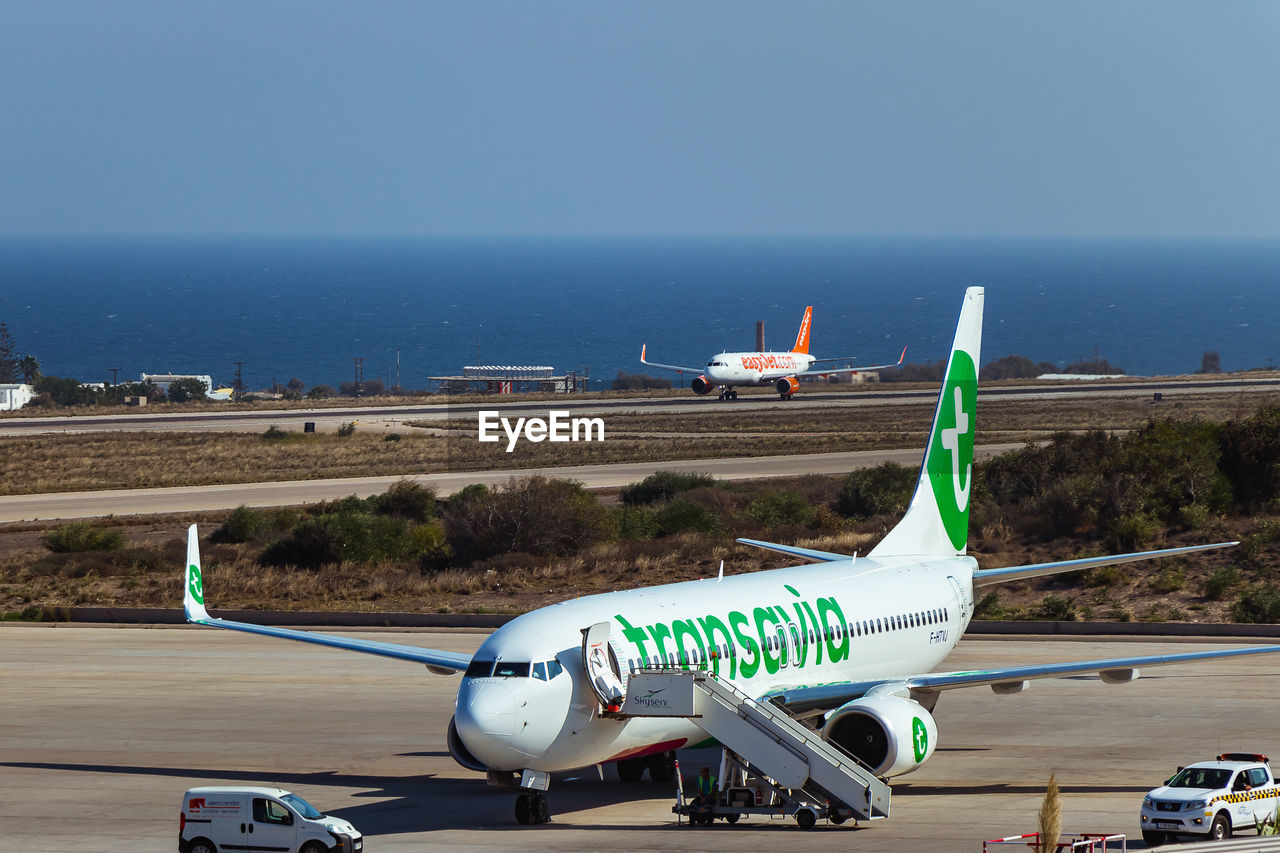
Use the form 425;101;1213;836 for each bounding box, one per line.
640;305;906;400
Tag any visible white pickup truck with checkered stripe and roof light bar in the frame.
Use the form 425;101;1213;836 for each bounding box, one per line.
1142;752;1280;844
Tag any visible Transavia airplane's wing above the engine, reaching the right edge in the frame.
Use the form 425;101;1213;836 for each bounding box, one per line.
765;646;1280;713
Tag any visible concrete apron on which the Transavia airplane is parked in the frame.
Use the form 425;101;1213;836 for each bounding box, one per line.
0;625;1280;853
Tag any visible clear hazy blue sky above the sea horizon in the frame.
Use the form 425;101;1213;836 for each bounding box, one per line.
0;0;1280;237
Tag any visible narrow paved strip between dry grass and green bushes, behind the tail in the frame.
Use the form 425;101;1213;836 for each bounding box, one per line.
0;444;1021;523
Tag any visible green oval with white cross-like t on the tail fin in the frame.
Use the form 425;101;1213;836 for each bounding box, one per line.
929;350;978;551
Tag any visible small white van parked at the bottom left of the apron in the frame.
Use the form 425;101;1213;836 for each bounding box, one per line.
178;786;365;853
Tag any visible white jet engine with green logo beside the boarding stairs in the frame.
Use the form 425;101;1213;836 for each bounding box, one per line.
822;695;938;777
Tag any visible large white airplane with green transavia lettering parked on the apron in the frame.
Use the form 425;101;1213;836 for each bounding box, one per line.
183;288;1280;822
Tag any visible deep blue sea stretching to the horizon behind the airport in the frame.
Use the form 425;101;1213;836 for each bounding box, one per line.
0;237;1280;388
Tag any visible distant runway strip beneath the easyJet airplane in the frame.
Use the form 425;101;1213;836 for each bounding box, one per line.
0;377;1280;435
